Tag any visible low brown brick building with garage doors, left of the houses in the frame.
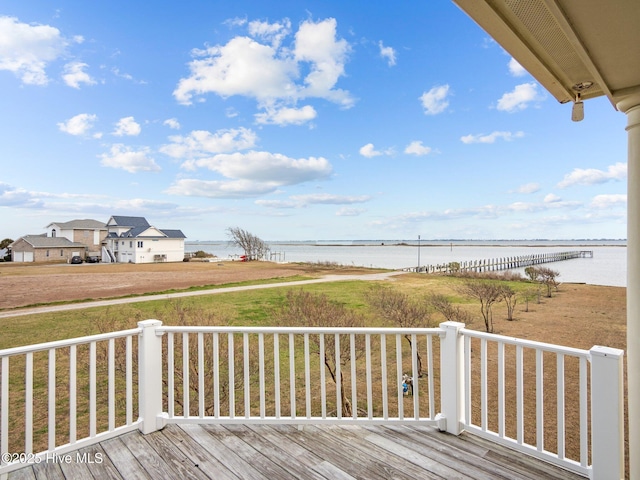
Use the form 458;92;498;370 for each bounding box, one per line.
10;235;87;262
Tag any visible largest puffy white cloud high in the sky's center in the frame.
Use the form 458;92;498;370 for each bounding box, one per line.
173;18;353;107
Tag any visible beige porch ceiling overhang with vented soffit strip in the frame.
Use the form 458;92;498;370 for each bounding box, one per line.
453;0;640;107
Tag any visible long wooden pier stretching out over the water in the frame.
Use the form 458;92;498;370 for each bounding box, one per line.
403;250;593;273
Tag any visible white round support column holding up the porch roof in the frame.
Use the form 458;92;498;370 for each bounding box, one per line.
616;94;640;480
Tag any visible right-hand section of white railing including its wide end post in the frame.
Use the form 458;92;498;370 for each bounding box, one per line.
462;329;624;478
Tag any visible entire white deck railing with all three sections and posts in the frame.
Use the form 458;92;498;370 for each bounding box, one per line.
0;320;624;478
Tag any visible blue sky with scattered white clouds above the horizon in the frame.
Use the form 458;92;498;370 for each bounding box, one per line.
0;0;627;240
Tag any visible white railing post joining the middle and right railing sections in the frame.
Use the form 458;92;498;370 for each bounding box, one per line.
436;322;465;435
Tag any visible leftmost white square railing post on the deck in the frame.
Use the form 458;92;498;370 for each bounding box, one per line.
138;320;164;434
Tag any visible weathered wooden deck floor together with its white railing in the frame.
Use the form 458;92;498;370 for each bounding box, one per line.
0;320;624;480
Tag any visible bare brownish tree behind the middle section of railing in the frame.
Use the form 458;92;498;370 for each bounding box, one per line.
274;290;366;417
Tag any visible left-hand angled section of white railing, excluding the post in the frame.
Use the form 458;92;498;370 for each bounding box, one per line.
0;328;141;474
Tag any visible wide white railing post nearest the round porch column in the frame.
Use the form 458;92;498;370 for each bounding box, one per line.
589;346;625;479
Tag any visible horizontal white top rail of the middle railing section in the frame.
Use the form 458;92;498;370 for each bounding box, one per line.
156;325;444;335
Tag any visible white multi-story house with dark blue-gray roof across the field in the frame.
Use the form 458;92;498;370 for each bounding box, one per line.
102;215;186;263
